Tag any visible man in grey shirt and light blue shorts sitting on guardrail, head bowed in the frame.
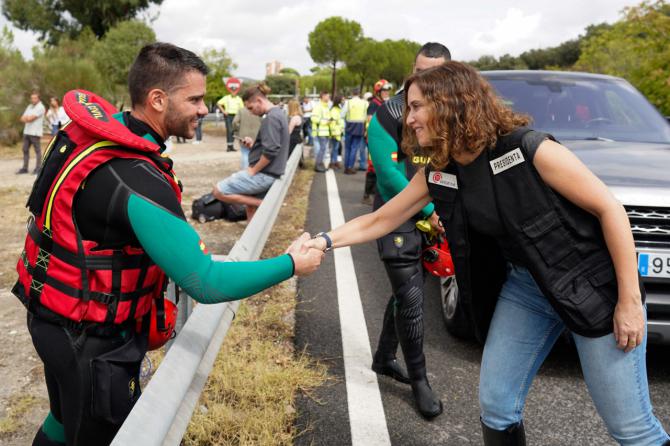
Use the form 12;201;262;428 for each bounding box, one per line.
212;83;289;220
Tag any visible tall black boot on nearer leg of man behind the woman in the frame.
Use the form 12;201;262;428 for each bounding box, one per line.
395;269;442;419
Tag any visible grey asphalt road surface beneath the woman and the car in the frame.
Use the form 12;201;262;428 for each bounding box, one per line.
296;168;670;446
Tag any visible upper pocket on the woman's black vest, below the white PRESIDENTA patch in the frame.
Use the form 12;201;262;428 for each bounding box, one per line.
521;211;573;266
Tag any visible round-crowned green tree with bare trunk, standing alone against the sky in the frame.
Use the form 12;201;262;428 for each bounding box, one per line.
307;17;363;95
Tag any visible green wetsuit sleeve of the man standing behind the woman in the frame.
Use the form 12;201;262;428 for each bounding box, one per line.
368;115;435;217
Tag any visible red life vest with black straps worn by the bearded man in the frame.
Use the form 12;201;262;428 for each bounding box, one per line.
13;90;181;324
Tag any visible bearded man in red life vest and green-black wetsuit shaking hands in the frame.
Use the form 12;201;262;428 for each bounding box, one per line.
13;43;322;446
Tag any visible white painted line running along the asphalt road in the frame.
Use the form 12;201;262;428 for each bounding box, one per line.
326;170;391;446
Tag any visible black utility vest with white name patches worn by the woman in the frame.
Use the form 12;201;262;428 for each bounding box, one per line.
426;128;645;342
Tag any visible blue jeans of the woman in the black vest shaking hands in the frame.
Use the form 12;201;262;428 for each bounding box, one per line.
479;266;669;446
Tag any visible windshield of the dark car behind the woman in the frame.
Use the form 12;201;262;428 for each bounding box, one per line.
484;73;670;143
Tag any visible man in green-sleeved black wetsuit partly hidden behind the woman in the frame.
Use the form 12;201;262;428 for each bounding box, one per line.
368;43;451;418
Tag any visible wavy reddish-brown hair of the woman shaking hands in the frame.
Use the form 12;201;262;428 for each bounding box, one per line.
402;61;530;170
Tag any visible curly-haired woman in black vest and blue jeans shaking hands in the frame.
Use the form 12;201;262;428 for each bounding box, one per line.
310;61;670;445
